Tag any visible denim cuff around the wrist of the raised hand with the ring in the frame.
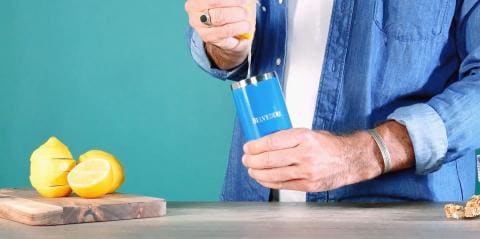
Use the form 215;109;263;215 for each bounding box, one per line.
190;30;248;80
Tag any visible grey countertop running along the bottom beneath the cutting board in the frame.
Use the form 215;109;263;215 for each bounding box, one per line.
0;203;480;239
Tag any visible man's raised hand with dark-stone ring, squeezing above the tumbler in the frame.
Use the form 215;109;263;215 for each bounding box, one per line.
185;0;254;70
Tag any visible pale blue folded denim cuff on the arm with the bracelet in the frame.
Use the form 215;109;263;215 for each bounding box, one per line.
388;103;448;175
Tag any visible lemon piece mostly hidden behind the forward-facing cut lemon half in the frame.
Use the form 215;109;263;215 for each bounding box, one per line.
78;150;125;193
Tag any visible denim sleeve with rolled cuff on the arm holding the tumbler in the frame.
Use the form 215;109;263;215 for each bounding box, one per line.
388;0;480;174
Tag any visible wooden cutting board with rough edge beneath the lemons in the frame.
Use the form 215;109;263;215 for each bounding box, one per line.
0;189;167;226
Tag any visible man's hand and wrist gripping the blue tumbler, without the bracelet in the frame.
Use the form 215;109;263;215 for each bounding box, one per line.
242;121;414;192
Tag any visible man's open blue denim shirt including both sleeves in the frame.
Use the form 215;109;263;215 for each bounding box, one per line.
188;0;480;202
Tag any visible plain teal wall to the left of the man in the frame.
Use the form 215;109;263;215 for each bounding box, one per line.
0;0;234;201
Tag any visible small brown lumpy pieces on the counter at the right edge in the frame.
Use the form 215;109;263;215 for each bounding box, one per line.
444;195;480;219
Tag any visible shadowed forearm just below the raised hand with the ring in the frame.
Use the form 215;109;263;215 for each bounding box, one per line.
205;43;248;71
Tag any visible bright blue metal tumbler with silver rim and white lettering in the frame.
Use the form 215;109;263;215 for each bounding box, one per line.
231;72;292;141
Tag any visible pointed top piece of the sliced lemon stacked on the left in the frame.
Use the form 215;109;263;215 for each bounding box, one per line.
30;137;73;161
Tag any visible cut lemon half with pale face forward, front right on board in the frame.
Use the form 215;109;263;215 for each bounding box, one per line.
67;158;113;198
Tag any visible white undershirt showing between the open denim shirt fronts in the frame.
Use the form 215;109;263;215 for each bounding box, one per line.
279;0;334;202
